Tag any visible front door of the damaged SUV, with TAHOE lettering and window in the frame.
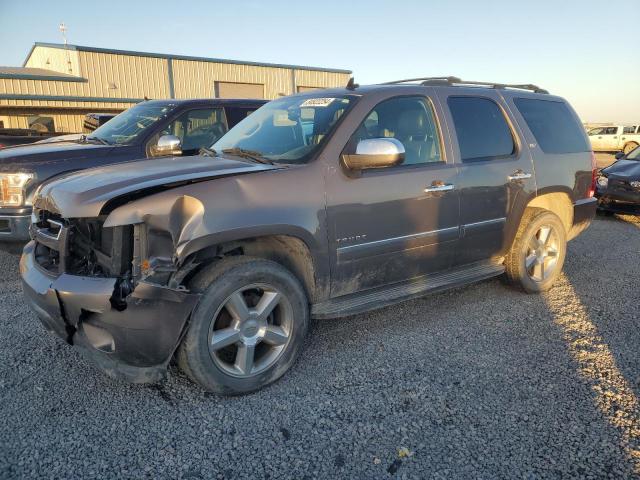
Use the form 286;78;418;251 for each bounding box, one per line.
327;96;459;296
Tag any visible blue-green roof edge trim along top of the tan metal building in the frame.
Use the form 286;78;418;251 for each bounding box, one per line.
24;42;352;74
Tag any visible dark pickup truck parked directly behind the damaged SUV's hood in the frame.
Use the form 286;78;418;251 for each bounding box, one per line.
0;99;266;241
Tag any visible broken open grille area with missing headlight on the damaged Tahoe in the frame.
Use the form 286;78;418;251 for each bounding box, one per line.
31;210;133;277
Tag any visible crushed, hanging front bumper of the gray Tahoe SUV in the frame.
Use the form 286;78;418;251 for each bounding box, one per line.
20;242;200;383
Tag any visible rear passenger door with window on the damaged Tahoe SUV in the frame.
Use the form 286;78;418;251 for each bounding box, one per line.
441;89;535;265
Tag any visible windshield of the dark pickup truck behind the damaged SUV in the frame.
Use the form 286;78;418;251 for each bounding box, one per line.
87;103;175;145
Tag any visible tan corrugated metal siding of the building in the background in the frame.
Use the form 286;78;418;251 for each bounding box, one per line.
0;45;349;125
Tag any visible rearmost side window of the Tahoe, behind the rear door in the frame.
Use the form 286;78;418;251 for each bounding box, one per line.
513;98;588;153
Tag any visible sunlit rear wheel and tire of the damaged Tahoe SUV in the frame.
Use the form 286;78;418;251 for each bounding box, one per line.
504;208;567;293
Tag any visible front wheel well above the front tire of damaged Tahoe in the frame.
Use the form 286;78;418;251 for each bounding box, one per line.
186;235;319;302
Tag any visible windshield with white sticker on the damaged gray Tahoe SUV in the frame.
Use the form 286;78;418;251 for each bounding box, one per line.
212;95;356;163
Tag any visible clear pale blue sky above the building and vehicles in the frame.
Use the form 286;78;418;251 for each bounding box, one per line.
0;0;640;123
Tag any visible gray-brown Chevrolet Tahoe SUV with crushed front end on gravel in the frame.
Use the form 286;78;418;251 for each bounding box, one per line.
20;77;596;394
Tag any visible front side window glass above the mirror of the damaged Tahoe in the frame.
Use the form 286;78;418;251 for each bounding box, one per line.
350;97;442;165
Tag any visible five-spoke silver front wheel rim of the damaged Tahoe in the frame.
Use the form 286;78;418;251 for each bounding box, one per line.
208;284;293;378
